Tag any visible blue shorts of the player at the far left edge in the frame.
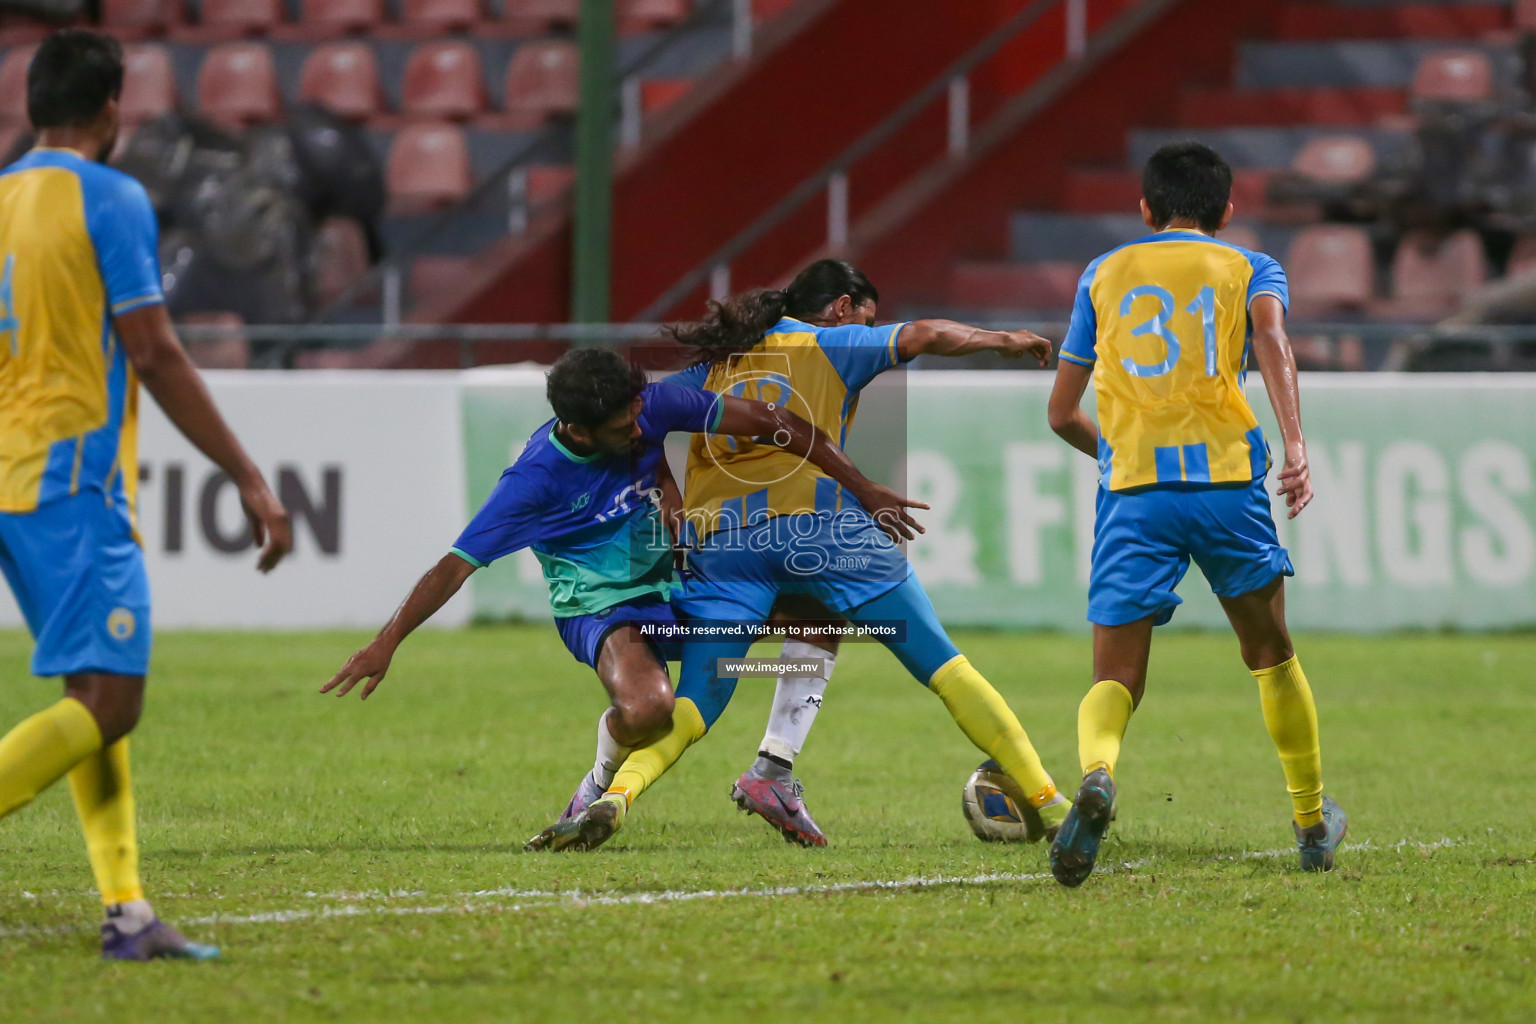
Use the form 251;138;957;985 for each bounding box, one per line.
0;490;152;676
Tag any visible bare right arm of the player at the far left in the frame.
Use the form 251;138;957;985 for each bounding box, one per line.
114;302;293;573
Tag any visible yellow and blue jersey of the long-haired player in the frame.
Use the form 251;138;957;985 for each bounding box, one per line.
685;316;903;536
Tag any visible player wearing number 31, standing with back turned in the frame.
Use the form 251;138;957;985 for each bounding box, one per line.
1051;143;1346;886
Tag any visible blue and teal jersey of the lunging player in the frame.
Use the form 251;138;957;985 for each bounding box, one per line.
453;384;725;617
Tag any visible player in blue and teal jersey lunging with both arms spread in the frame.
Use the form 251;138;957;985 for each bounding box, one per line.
321;348;926;820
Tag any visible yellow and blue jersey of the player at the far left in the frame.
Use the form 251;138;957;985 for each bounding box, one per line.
0;149;164;513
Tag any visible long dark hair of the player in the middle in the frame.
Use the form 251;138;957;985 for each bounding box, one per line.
662;259;880;362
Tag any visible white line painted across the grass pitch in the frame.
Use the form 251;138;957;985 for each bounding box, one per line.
0;838;1464;938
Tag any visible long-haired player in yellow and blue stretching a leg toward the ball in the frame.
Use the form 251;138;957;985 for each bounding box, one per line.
536;259;1068;851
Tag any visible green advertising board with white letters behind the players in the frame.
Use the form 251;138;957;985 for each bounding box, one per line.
462;372;1536;631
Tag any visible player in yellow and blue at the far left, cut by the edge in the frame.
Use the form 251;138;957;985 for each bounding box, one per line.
0;31;290;960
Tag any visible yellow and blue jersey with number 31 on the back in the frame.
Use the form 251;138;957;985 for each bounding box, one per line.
1061;230;1290;491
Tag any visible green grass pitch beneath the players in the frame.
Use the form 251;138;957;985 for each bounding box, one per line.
0;626;1536;1024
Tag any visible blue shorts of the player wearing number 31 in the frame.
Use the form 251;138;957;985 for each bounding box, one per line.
1087;477;1295;626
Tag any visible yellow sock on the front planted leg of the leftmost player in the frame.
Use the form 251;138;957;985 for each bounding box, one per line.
69;737;144;907
